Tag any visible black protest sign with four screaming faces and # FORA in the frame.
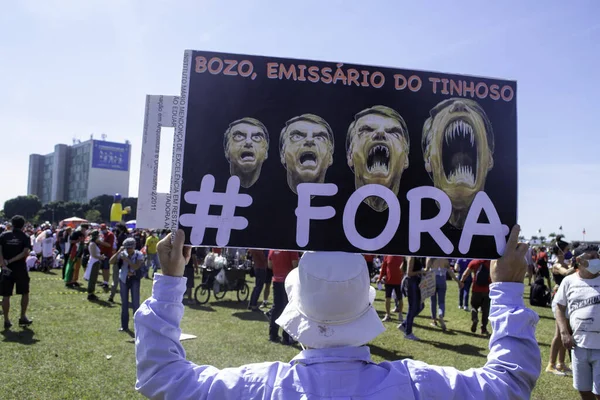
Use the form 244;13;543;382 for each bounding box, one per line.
156;51;517;258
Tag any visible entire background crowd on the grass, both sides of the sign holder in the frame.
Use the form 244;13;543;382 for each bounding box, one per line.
0;216;600;396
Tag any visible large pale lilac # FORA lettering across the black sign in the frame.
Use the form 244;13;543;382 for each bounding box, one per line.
184;175;509;255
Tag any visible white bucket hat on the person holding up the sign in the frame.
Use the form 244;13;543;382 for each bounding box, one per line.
276;252;385;349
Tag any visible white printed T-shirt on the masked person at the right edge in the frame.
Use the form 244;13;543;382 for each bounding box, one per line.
554;273;600;349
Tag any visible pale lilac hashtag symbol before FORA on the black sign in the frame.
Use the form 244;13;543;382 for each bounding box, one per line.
179;175;252;247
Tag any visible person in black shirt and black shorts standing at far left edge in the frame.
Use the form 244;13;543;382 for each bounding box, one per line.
0;215;32;329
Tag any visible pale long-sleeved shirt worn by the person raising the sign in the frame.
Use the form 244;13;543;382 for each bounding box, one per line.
134;274;542;400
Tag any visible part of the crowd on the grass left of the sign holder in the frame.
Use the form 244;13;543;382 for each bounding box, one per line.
0;216;168;332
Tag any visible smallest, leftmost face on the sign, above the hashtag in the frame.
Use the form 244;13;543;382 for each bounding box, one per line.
223;118;269;188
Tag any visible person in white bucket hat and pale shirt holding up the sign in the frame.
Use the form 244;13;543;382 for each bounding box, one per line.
135;226;541;400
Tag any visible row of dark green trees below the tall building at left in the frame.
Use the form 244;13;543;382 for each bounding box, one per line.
0;194;137;223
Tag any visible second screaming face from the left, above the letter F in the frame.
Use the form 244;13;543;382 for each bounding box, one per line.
279;114;334;193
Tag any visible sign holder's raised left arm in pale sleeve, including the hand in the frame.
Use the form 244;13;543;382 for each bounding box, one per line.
134;230;253;400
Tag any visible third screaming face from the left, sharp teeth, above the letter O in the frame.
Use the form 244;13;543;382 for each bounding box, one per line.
346;106;410;212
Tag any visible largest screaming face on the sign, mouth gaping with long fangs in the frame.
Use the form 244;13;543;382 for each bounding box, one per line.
421;98;494;228
